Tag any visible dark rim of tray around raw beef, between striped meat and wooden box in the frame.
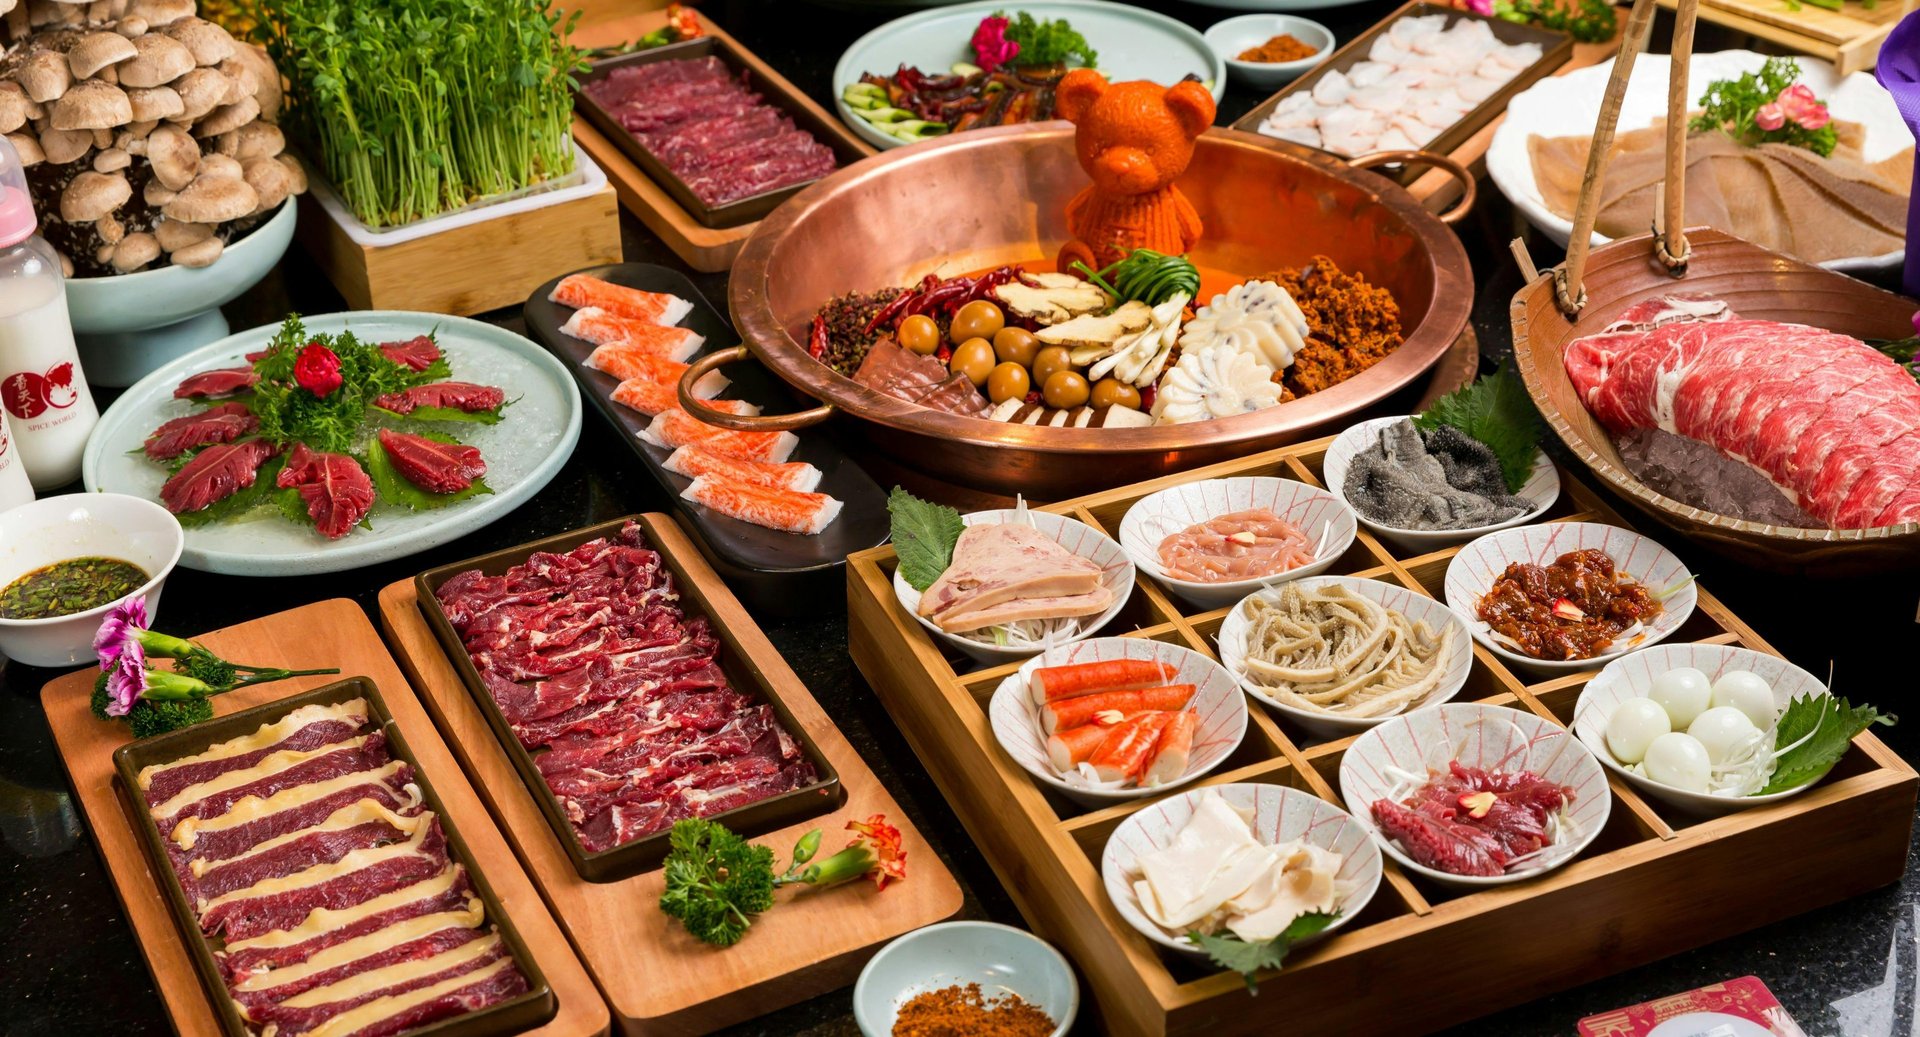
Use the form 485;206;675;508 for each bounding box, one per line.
415;515;847;881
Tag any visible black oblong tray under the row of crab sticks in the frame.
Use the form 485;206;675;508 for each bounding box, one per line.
524;263;891;615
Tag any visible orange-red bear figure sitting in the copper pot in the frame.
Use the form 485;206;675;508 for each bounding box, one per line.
1054;69;1213;271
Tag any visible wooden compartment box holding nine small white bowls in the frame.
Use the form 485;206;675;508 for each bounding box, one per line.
847;440;1920;1037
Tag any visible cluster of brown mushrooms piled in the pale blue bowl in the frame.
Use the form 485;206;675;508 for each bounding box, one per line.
0;0;307;275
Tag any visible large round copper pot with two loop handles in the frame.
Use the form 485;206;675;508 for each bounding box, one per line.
706;123;1473;499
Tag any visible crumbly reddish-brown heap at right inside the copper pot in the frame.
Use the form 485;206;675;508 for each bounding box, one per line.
1267;255;1404;399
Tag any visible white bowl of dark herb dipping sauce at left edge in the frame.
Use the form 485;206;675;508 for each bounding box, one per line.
0;494;182;666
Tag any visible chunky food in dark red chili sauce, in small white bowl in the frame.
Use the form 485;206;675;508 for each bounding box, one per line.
1475;547;1661;661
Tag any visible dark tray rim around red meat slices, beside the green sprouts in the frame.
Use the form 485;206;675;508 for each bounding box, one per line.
574;36;866;227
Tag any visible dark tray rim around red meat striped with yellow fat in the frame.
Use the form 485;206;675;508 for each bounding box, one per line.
113;676;559;1037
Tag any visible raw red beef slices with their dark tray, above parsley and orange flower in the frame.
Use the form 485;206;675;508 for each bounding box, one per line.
415;519;847;881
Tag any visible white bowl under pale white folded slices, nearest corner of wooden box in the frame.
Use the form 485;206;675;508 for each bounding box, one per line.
1100;784;1380;956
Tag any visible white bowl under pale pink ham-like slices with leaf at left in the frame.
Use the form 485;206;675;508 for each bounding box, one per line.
893;507;1135;664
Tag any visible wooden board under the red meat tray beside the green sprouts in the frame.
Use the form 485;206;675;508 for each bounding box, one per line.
560;6;876;272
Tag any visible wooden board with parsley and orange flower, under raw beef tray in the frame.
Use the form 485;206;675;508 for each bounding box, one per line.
380;515;962;1037
